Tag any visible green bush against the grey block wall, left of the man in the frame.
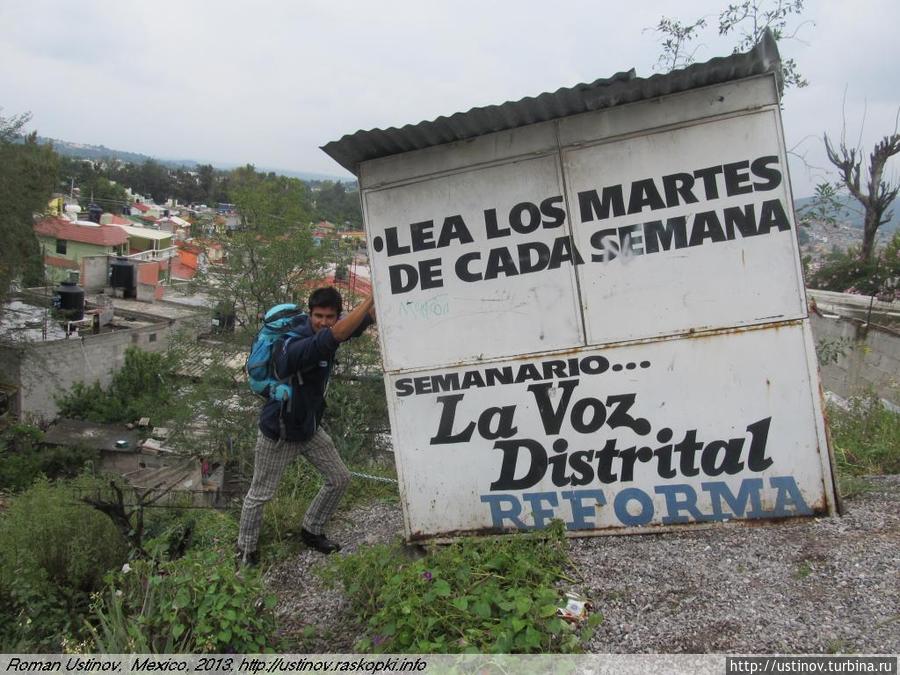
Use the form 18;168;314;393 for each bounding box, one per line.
57;347;173;424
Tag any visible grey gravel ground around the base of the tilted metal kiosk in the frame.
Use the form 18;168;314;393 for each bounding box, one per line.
266;476;900;654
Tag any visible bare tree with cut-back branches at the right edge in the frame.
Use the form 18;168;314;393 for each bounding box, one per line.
825;125;900;263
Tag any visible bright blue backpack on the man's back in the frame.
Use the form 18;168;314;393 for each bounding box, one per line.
246;303;304;404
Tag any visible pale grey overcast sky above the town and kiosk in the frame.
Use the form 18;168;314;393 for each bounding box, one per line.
0;0;900;197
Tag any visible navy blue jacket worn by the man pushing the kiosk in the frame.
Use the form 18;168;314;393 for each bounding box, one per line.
259;314;374;441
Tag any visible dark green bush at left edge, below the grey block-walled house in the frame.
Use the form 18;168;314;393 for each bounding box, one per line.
0;424;97;491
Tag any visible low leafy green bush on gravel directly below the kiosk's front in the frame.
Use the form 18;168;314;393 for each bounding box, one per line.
324;523;600;653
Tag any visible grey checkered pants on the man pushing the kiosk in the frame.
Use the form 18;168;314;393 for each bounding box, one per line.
238;429;350;552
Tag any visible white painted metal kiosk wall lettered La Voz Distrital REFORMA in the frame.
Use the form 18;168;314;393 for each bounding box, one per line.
360;75;835;538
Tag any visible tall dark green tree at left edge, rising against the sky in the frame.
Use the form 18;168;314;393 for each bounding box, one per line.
0;108;59;300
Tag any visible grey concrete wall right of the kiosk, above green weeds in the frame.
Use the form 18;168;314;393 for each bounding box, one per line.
810;312;900;405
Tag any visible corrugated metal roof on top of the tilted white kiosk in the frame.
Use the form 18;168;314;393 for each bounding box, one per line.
322;30;782;175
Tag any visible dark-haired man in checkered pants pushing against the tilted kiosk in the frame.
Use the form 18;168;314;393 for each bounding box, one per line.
238;287;375;565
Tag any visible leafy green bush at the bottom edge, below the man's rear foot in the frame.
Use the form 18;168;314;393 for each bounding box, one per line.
92;549;277;654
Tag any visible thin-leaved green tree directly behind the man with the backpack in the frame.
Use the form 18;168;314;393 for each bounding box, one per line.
168;165;387;478
